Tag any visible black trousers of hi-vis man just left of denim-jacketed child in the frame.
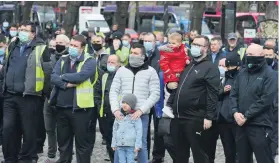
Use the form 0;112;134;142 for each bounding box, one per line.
104;112;115;163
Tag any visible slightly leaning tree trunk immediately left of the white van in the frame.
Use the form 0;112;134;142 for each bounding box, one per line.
63;1;82;37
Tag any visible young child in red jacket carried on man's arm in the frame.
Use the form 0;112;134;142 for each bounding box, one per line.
159;32;190;118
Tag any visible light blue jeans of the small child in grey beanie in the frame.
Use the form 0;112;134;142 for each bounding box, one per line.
117;147;135;163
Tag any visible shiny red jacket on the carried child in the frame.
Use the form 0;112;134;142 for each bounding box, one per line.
159;44;190;84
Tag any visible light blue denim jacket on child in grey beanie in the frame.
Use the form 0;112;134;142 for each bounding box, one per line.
111;114;142;149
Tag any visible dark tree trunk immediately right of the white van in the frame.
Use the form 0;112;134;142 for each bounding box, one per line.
115;1;130;33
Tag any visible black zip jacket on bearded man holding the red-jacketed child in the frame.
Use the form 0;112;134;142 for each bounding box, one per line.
173;57;220;120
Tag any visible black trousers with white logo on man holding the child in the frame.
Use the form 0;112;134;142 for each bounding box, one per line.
171;119;209;163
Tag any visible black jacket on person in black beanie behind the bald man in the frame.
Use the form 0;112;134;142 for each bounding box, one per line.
217;70;238;123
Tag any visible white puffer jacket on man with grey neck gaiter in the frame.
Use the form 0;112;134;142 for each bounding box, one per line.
109;64;160;114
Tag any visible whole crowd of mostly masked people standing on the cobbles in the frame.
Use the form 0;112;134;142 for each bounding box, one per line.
0;22;278;163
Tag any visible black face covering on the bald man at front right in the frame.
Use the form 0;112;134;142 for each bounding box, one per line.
246;56;265;72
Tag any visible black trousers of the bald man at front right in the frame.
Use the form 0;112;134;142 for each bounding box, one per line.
236;125;274;163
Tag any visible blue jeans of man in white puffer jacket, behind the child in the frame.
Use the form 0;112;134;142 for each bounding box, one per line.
114;114;149;163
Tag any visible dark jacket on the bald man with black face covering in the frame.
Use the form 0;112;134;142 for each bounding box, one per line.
230;63;277;127
